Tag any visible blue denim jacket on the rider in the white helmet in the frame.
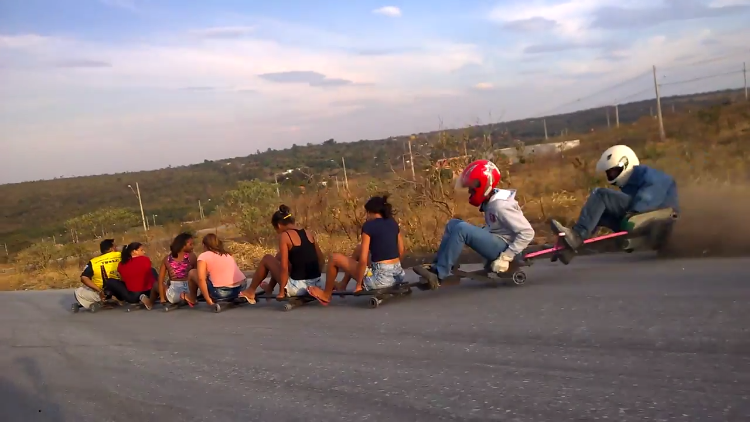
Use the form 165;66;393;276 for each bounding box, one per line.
620;165;680;213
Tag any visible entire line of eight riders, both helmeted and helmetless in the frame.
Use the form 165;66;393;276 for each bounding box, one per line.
75;145;678;309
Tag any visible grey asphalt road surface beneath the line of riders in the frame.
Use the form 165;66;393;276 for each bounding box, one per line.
0;254;750;422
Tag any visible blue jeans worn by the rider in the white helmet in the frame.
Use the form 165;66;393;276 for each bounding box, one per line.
573;188;631;239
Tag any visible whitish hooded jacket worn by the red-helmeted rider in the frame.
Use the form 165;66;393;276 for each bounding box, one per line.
479;189;534;255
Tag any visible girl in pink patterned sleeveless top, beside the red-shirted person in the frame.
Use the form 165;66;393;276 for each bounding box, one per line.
159;233;198;303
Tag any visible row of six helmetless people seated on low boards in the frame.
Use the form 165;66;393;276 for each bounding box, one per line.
75;196;406;309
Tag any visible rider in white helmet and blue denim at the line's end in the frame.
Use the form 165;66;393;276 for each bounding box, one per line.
551;145;679;264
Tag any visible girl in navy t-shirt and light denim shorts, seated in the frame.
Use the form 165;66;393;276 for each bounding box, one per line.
307;195;406;305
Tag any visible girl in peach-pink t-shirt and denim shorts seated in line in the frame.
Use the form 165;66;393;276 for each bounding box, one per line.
180;233;247;307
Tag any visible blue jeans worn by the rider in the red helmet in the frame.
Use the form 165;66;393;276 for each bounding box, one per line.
434;218;508;280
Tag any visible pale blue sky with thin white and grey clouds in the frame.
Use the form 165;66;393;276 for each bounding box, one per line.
0;0;750;183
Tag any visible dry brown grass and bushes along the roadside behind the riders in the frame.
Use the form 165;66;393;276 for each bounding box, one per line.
0;94;750;290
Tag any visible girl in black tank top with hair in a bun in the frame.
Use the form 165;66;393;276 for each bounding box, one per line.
240;205;325;304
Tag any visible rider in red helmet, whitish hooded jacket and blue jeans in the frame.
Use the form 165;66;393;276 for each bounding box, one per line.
414;160;534;289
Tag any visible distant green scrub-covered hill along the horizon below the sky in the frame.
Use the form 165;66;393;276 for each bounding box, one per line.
0;85;740;251
